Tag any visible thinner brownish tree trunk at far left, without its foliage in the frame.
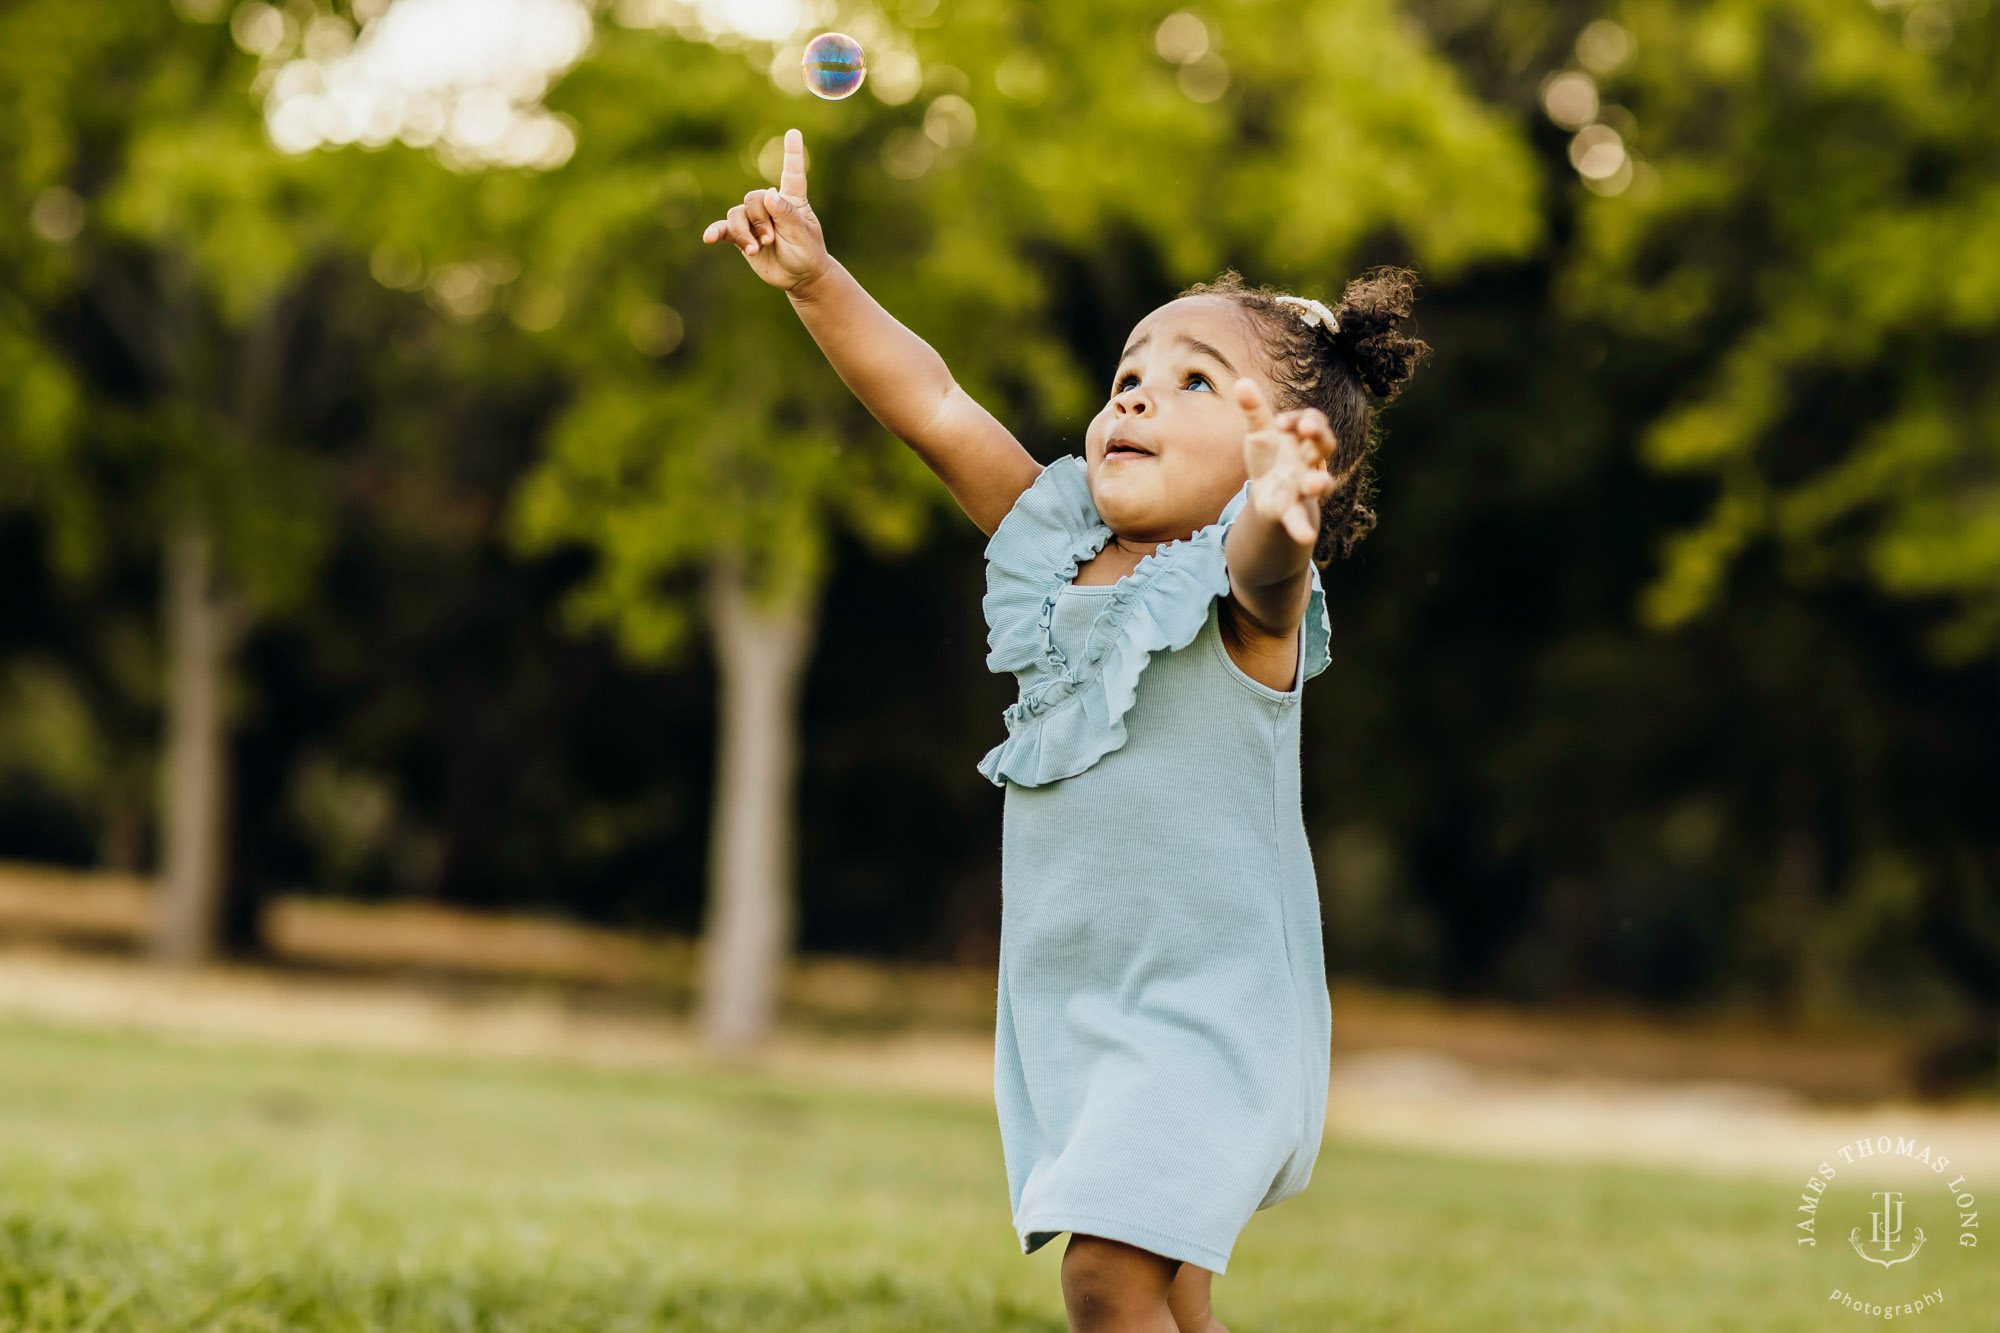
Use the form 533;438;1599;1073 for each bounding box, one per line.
152;520;232;967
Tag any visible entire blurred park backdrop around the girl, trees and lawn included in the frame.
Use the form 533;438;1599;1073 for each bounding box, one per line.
0;0;2000;1333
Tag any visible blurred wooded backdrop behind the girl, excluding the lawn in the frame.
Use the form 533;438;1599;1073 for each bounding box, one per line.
0;0;2000;1089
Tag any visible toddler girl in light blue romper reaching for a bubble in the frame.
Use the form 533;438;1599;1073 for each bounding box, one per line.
702;130;1428;1333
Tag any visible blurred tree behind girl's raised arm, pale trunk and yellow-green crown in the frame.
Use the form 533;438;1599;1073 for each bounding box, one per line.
496;2;1536;1047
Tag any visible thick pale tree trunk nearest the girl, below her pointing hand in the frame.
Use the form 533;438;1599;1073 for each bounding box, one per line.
700;560;814;1051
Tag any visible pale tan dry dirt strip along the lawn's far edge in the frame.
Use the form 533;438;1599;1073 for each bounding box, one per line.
0;932;2000;1181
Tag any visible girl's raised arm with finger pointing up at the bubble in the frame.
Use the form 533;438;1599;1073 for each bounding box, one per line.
702;130;1042;536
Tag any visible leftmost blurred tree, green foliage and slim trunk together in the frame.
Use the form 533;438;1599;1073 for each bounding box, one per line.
0;0;368;965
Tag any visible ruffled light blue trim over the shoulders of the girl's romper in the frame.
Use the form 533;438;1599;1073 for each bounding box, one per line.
980;454;1332;787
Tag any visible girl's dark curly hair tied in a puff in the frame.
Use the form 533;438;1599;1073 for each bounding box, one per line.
1180;268;1430;568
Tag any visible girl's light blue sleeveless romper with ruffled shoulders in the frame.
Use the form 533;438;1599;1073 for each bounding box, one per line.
980;454;1332;1273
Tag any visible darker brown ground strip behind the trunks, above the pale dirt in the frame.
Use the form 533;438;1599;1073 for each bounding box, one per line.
0;863;1916;1105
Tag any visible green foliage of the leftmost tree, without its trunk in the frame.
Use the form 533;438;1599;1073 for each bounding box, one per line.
0;0;372;604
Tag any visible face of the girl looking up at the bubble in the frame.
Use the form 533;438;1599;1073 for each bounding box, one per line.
1084;296;1276;542
